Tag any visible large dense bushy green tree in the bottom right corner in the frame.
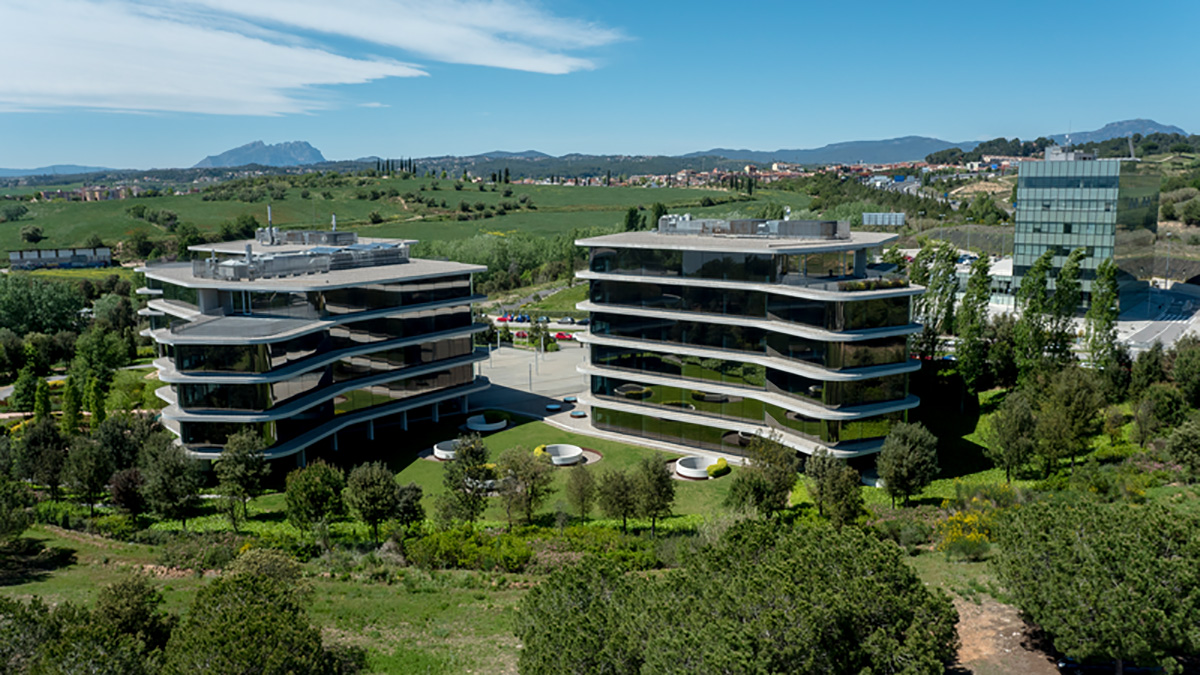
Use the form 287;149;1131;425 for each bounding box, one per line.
995;501;1200;673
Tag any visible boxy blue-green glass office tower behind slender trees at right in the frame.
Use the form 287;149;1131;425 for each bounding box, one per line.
1013;145;1160;309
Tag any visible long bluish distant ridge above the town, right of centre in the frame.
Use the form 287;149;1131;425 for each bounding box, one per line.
683;136;974;165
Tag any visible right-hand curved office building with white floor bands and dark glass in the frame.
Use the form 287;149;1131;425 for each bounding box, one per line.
576;216;924;456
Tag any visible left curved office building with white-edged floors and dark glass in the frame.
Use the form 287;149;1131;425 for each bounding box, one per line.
138;228;487;464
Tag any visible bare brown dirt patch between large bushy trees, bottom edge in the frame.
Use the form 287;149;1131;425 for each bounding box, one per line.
952;597;1058;675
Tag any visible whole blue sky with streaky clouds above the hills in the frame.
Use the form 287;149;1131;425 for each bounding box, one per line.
0;0;1200;168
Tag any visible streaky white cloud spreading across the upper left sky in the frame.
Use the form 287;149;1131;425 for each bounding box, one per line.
0;0;619;115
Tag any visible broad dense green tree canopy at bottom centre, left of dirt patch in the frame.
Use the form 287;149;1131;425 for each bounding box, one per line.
516;521;958;675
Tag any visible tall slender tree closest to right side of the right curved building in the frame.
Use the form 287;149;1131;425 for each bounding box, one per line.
908;240;959;359
